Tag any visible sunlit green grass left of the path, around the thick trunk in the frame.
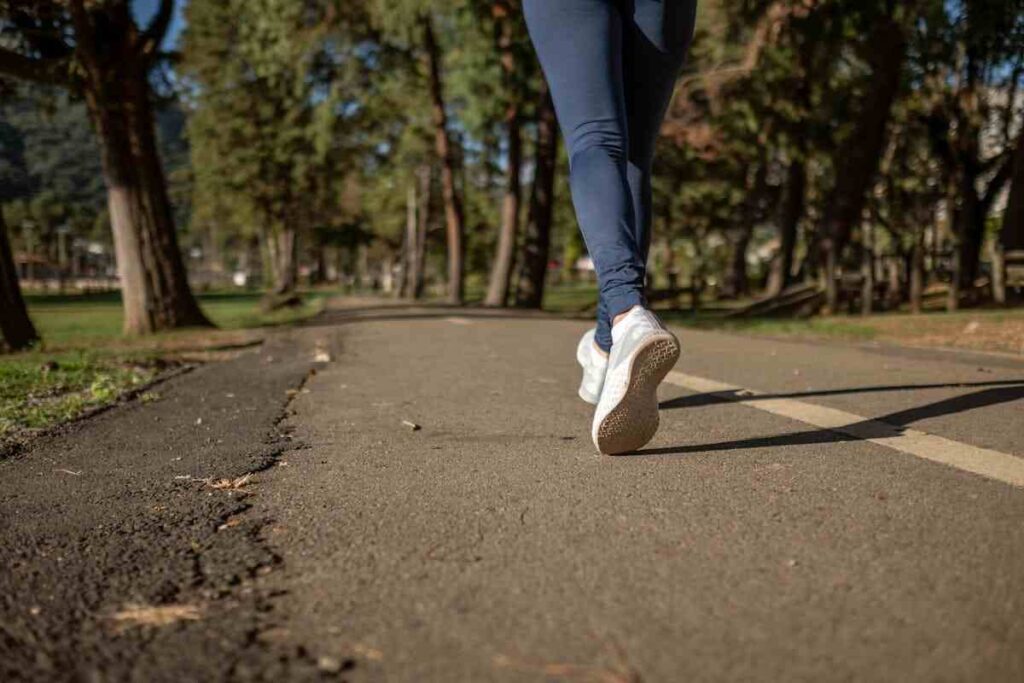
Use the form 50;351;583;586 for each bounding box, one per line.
0;291;331;446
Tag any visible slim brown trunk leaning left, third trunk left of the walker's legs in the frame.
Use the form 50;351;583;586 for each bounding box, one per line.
420;14;465;305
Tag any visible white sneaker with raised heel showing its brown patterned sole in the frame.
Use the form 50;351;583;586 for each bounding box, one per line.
591;306;679;455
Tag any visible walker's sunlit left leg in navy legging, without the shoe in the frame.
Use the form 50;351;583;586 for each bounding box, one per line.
523;0;644;352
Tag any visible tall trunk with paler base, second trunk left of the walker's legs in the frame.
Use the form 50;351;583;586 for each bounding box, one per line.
483;1;522;306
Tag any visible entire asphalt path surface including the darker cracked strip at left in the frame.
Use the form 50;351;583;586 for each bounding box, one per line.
0;305;1024;682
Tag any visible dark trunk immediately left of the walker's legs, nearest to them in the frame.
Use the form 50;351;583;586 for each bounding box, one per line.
516;85;558;308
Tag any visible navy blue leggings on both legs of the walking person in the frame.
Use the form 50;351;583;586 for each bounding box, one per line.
523;0;696;351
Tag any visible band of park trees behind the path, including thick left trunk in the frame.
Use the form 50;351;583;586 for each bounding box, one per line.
0;0;1024;352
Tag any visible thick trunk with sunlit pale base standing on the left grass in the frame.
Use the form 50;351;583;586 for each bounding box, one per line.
76;4;210;334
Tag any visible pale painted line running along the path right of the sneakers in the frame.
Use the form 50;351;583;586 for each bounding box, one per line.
665;371;1024;487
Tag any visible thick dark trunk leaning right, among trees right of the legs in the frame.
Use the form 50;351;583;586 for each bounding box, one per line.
820;17;906;311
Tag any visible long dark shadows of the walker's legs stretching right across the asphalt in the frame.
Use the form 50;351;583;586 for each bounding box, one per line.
631;381;1024;456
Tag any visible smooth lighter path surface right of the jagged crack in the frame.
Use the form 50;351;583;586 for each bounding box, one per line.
264;301;1024;681
